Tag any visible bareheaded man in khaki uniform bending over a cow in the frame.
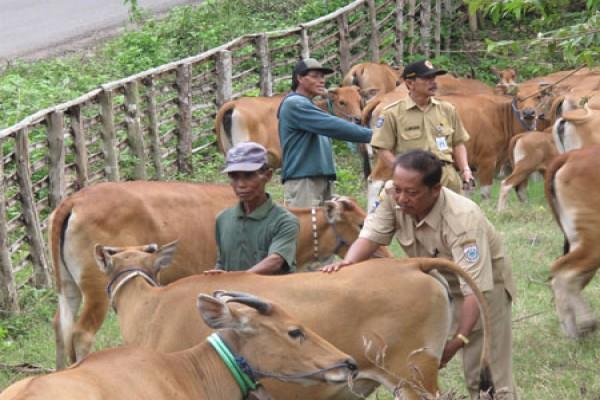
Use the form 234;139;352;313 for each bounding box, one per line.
322;150;517;399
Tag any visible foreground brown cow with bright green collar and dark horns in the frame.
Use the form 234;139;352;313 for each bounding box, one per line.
0;292;356;400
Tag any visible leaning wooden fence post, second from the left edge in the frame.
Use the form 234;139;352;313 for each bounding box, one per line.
15;128;51;288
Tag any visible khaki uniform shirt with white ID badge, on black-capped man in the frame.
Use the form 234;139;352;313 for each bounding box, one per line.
371;96;469;163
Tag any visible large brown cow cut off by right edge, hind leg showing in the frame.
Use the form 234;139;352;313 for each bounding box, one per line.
545;145;600;338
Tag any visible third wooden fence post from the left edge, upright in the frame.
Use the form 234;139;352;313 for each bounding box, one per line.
46;111;65;209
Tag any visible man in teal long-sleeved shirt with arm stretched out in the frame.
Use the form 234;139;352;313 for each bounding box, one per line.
277;58;371;207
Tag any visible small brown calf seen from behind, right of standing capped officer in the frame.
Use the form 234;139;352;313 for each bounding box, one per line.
498;131;558;212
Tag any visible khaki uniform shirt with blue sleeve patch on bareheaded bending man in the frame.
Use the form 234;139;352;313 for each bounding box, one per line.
360;181;515;298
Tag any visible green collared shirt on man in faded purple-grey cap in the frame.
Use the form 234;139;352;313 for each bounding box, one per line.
215;195;300;272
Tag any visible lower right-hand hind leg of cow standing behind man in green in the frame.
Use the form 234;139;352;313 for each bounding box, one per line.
70;289;108;361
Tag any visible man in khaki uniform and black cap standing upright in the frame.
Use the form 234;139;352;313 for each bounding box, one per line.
371;60;473;193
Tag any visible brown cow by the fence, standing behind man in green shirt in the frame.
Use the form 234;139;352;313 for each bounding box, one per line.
49;181;389;369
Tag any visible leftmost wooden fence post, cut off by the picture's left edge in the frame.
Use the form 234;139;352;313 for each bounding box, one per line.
0;142;19;314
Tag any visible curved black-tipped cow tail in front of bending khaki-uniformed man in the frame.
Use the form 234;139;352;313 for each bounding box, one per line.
411;258;495;395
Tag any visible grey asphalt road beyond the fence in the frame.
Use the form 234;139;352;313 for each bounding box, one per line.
0;0;200;60
